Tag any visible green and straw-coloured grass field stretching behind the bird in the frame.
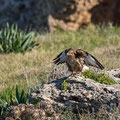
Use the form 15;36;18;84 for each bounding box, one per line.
0;27;120;101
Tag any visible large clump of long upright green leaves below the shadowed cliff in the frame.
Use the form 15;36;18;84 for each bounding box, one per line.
0;24;36;53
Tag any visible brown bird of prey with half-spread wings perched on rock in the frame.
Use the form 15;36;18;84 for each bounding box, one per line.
53;48;104;73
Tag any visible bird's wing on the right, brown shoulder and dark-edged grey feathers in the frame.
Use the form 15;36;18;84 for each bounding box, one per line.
76;49;104;70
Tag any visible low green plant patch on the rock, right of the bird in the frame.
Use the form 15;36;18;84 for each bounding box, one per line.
82;71;116;85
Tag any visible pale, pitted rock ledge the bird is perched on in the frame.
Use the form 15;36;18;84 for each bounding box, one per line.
32;73;120;112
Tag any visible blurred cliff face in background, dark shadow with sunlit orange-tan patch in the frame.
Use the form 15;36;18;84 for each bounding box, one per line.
0;0;120;31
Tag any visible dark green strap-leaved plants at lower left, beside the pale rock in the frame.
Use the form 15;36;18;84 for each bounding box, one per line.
0;86;40;116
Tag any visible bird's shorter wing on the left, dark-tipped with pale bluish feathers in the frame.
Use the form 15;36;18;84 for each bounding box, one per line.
53;49;70;65
